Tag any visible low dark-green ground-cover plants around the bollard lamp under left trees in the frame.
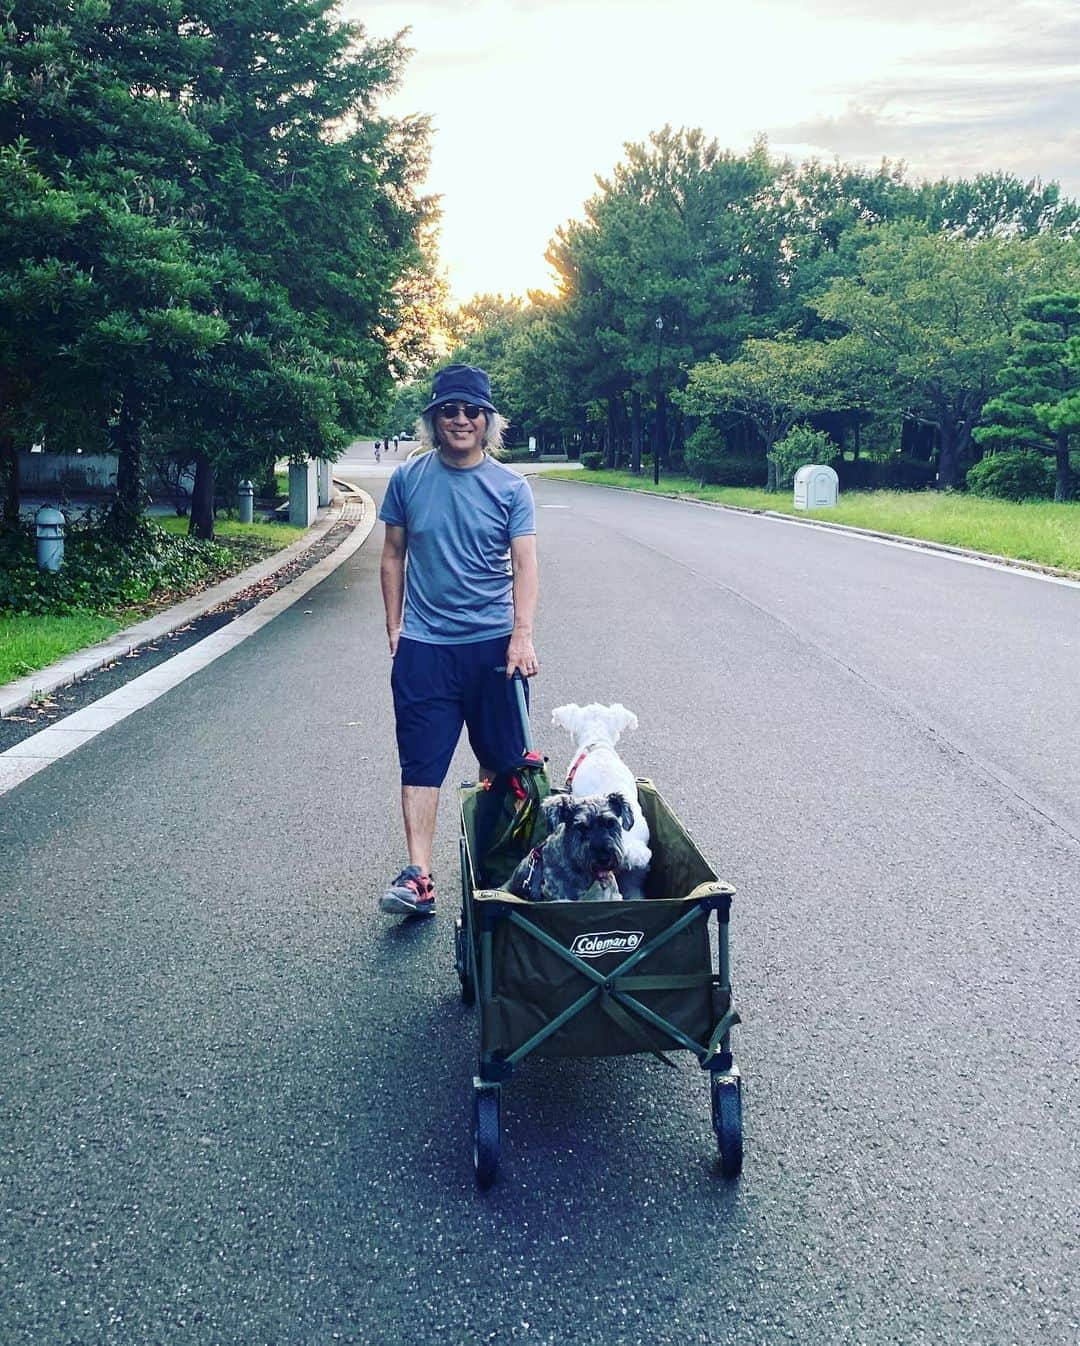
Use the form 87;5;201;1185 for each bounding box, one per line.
0;520;229;615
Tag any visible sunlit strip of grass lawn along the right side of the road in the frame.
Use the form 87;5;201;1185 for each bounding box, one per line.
544;471;1080;572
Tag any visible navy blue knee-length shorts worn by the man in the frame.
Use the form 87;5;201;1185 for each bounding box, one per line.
391;635;529;786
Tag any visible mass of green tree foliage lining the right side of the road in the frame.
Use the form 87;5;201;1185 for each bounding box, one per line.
385;127;1080;500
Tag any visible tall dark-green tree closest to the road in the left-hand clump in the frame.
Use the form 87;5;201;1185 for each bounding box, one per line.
160;0;432;536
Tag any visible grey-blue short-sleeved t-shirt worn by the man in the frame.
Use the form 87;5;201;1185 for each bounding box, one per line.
378;452;536;645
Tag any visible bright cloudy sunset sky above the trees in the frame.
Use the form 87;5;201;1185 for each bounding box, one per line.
339;0;1080;302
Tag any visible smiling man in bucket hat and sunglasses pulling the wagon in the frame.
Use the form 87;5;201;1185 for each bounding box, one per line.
378;365;539;915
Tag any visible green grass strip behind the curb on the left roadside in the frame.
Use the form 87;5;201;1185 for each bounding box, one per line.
0;518;307;686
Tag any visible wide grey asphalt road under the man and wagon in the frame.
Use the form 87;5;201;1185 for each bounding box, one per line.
0;479;1080;1346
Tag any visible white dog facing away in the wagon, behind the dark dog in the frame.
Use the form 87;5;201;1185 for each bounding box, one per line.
551;703;653;898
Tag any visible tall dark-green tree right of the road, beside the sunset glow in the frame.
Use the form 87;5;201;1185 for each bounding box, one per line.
548;127;781;466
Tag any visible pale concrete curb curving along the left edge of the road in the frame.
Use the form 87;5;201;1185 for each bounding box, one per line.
0;482;376;719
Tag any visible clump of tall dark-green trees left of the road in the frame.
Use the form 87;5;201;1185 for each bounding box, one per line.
0;0;434;536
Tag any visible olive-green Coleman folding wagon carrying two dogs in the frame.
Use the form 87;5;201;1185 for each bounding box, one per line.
455;779;742;1187
